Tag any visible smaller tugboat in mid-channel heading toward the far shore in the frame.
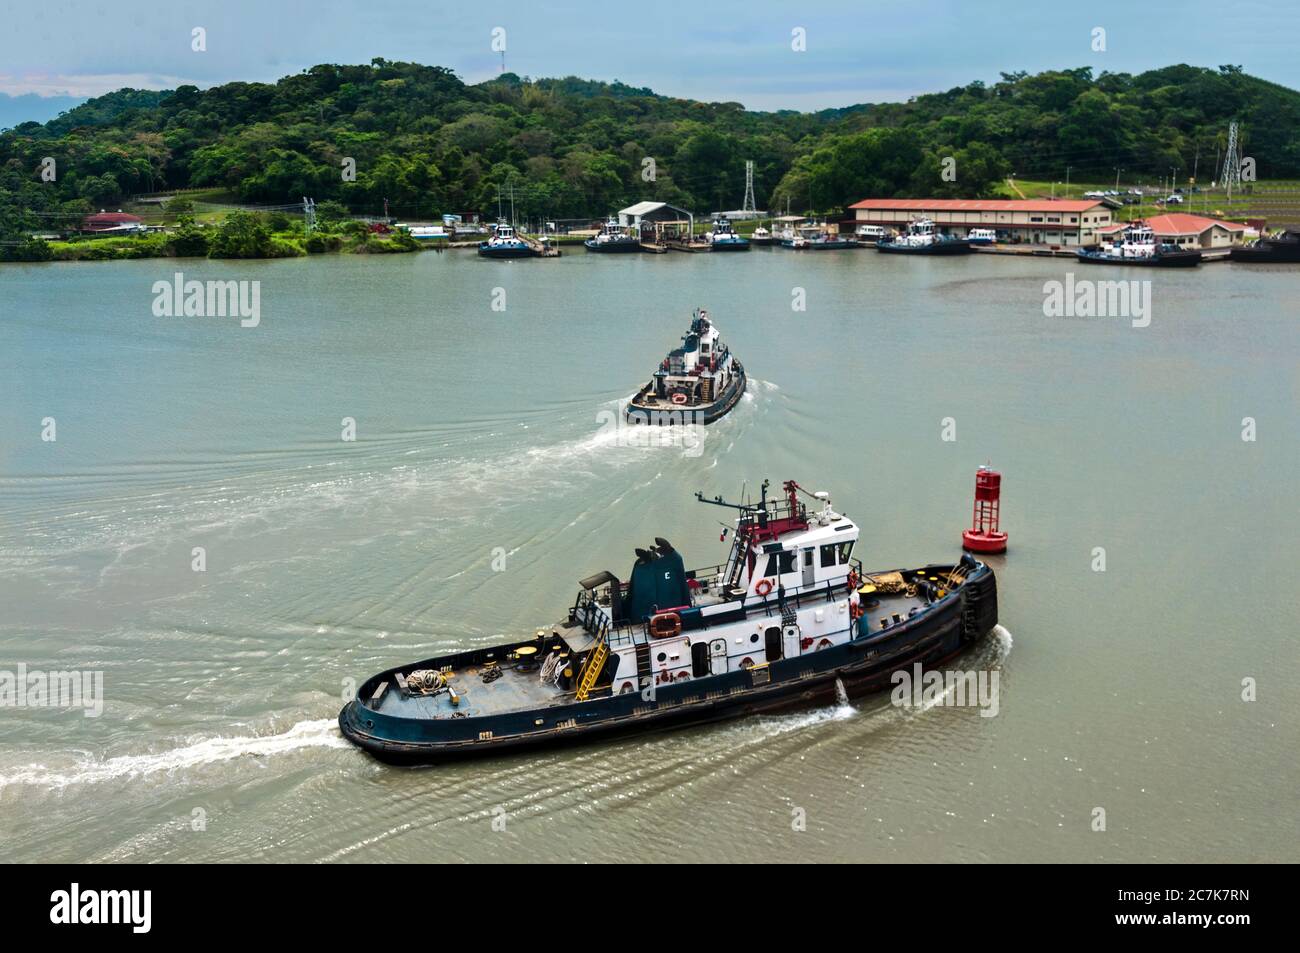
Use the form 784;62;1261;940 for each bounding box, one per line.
627;308;745;424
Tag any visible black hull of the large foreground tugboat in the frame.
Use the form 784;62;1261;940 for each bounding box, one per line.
338;567;997;764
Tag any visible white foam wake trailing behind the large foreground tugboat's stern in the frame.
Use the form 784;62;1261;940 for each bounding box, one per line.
0;718;348;792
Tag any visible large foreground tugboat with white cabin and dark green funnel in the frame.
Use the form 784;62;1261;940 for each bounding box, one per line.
338;480;997;764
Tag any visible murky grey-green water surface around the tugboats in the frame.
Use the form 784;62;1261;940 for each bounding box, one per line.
0;250;1300;862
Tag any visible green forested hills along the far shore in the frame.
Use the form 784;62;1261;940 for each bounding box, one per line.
0;60;1300;231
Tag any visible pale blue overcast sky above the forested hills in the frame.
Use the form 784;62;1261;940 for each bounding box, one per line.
0;0;1300;126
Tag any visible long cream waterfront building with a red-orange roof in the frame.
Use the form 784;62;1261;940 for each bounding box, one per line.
849;199;1112;244
